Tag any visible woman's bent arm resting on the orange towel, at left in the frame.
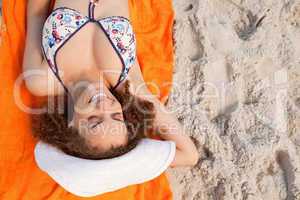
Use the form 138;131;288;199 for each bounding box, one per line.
23;0;63;96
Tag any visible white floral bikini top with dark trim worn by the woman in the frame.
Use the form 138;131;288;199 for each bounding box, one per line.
42;1;136;92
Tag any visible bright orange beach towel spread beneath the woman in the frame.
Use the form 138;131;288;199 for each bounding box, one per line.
0;0;174;200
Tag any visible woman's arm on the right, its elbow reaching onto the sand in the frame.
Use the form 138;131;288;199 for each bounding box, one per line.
130;63;199;167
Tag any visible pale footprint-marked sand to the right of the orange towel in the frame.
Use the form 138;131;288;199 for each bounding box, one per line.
168;0;300;200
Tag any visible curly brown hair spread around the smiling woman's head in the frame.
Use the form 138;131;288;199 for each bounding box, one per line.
32;81;155;160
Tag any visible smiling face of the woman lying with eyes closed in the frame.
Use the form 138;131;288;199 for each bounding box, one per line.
71;83;128;151
